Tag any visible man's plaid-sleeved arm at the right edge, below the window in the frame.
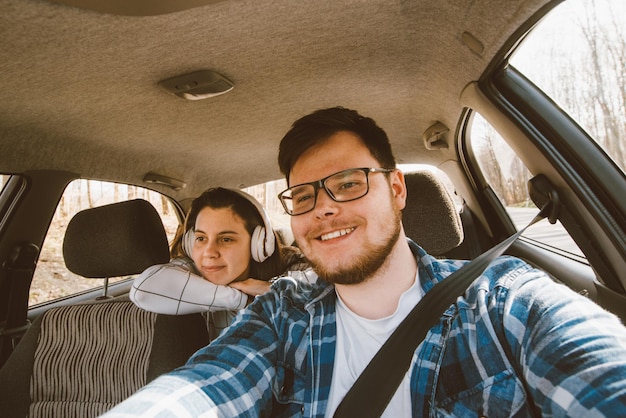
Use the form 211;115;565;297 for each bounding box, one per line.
503;271;626;416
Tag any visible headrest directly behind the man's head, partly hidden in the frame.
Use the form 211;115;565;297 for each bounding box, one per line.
402;171;463;255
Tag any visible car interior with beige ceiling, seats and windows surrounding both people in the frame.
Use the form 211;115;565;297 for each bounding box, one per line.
0;0;626;417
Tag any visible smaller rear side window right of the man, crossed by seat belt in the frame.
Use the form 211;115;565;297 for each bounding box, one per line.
471;114;584;258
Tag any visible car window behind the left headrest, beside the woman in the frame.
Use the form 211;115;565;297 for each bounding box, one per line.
28;179;179;306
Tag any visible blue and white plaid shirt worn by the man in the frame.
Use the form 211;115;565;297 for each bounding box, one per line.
107;243;626;417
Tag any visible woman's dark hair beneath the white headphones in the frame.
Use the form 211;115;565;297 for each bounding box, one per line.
170;187;302;280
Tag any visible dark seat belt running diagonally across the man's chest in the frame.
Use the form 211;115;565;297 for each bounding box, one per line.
333;202;557;418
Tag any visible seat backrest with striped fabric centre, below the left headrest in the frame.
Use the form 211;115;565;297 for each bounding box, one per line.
0;301;209;417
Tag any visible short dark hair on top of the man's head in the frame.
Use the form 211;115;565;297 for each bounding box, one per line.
278;107;396;183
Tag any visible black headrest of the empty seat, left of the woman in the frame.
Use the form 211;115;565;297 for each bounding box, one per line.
63;199;169;278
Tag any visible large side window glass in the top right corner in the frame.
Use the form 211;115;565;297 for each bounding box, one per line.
510;0;626;171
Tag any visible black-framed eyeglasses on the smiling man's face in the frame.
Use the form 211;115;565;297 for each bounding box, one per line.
278;168;394;216
